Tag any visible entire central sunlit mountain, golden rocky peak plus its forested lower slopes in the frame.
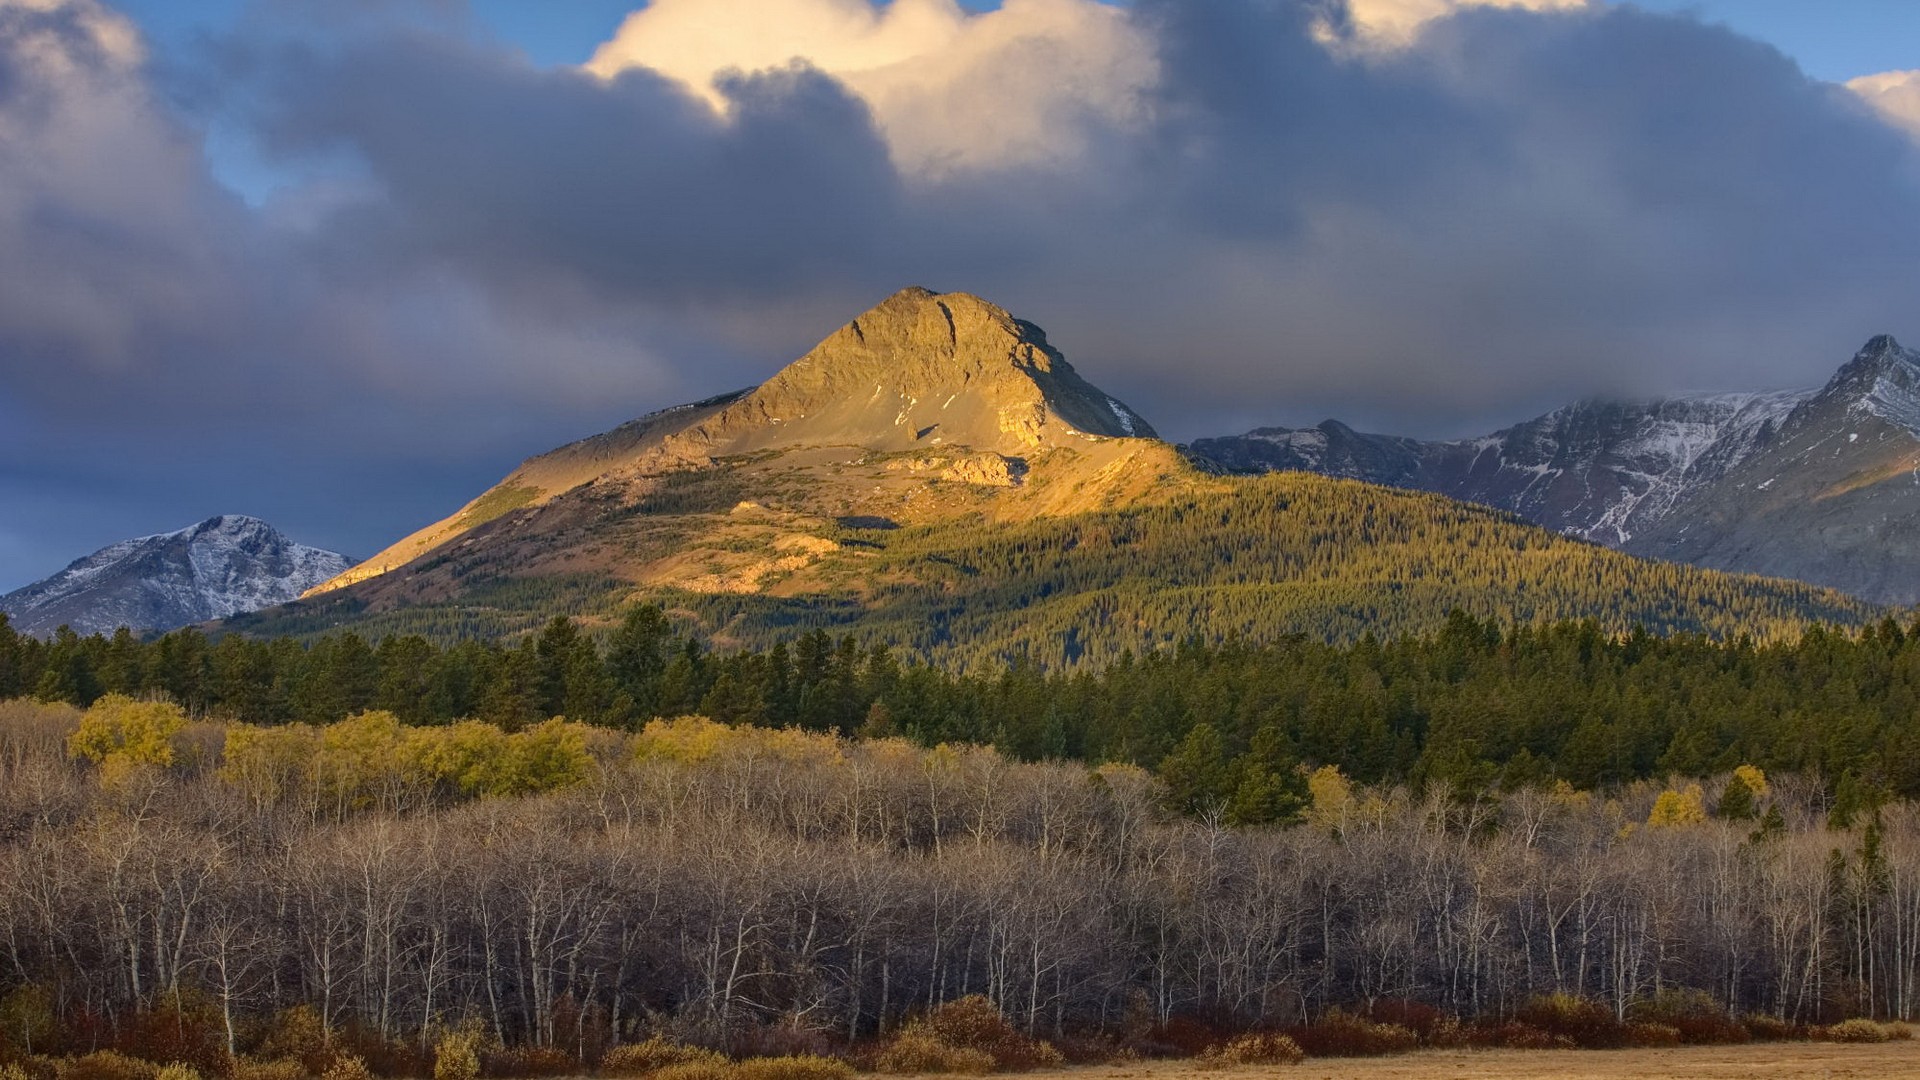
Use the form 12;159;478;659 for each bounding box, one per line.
240;288;1876;667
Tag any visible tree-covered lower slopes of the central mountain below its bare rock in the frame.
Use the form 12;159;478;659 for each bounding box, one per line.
228;465;1880;671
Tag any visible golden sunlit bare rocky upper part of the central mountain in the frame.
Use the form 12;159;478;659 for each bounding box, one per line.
313;288;1175;603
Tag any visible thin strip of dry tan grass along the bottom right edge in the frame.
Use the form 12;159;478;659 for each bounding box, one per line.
1021;1042;1920;1080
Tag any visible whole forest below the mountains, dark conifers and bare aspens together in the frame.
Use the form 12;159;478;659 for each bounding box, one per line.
11;605;1920;1080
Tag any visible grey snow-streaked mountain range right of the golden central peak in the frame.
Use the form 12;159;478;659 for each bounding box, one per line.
1190;336;1920;605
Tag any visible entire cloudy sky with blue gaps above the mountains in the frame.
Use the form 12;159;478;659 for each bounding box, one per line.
0;0;1920;592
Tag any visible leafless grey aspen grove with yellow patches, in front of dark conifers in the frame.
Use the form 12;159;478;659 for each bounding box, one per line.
0;694;1920;1076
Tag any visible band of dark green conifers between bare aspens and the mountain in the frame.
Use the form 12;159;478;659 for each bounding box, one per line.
11;605;1920;807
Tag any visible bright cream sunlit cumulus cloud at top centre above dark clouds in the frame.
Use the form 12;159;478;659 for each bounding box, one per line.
588;0;1156;175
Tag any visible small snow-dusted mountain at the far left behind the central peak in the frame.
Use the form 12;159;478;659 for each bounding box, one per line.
0;515;353;636
